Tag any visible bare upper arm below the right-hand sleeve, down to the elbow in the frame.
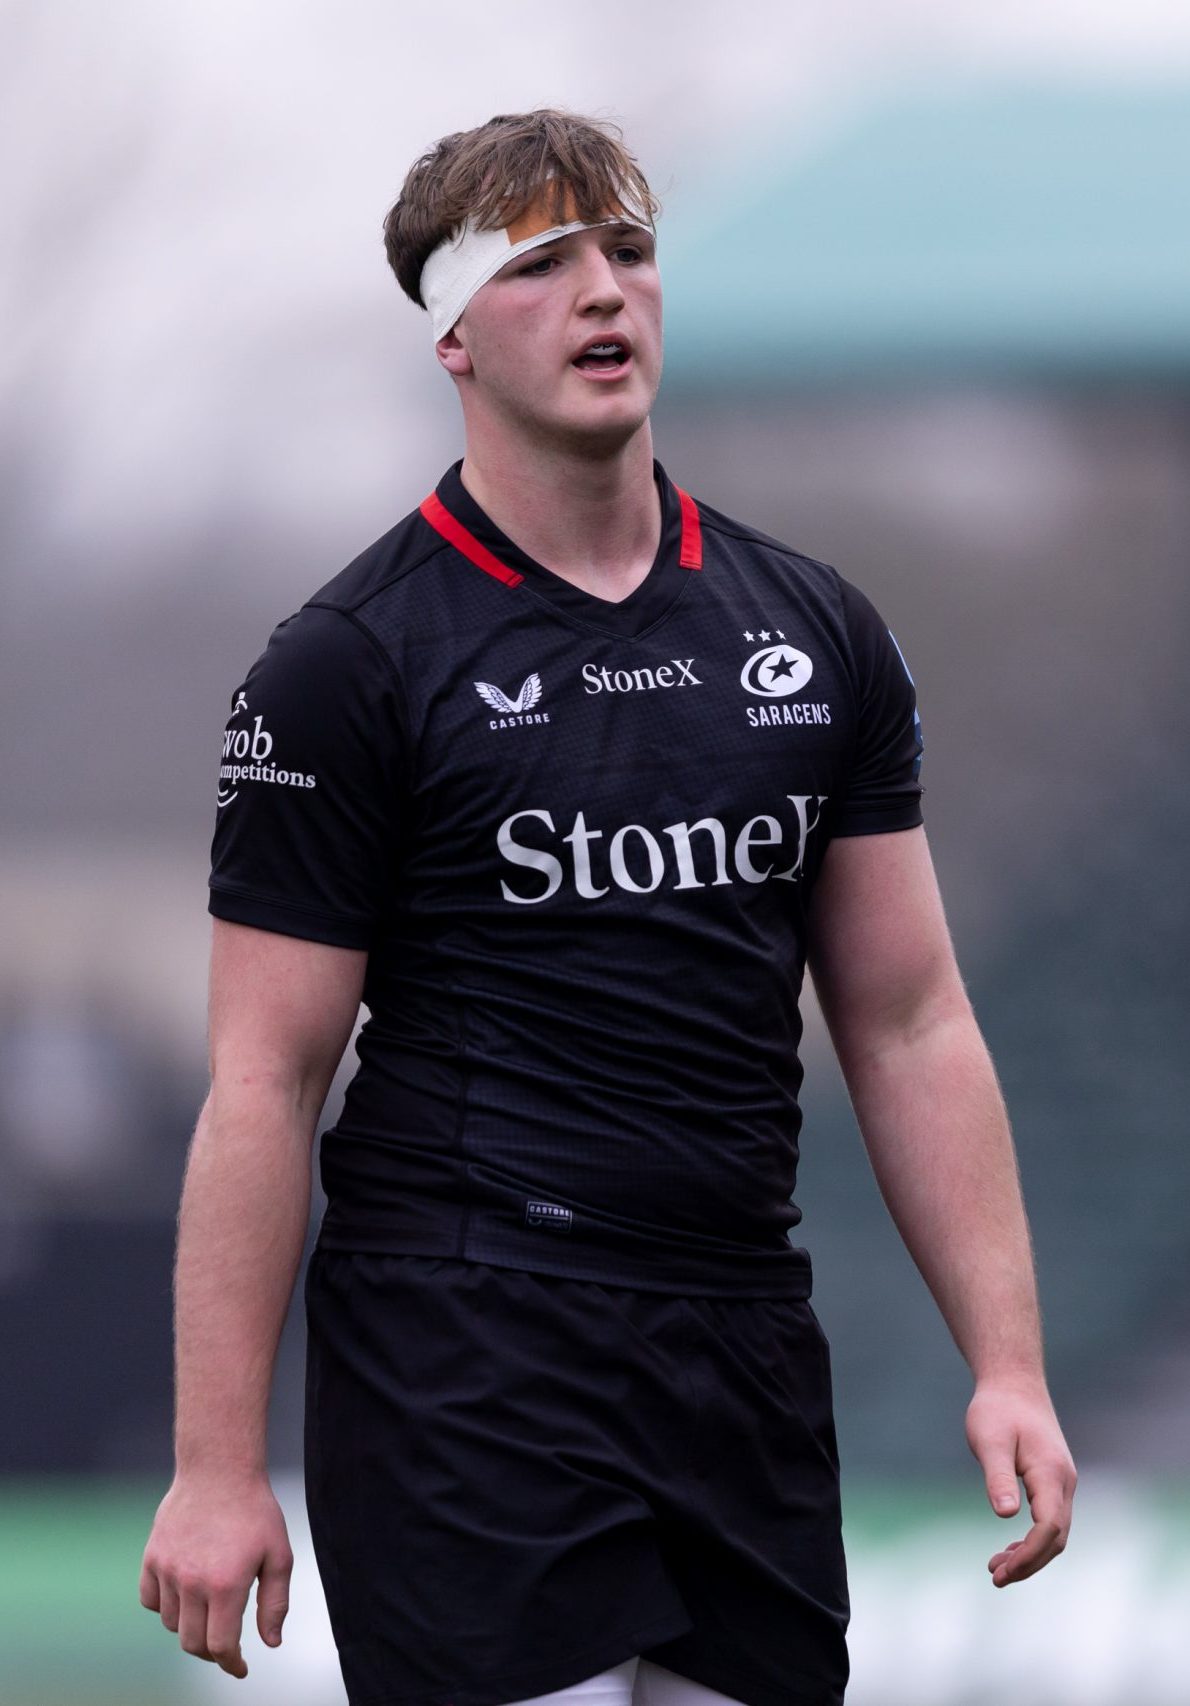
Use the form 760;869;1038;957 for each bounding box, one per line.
810;827;967;1066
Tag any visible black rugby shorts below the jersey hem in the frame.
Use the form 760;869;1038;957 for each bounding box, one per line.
305;1250;847;1706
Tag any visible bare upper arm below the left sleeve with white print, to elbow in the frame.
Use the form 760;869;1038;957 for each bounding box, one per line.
210;918;368;1117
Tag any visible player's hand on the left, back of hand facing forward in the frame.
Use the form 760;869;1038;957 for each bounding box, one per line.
140;1476;293;1677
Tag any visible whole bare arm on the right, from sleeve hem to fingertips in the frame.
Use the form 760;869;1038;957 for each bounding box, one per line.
810;829;1076;1587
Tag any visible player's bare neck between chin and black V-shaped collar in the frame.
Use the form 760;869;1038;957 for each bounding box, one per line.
462;421;661;602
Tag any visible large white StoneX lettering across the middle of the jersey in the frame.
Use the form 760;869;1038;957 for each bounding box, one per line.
496;793;827;906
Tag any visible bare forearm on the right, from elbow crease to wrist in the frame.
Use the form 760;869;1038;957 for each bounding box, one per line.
841;991;1043;1380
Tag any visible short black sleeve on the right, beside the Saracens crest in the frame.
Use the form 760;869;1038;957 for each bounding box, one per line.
834;580;922;836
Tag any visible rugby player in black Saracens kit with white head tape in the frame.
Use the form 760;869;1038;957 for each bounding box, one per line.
142;111;1074;1706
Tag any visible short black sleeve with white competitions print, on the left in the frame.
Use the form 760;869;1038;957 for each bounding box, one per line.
210;606;406;949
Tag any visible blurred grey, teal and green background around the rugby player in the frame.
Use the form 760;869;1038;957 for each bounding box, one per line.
0;0;1190;1706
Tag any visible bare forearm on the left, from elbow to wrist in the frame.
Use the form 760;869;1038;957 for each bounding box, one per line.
174;1088;312;1476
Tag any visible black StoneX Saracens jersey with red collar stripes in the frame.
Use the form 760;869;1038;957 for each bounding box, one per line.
210;464;921;1297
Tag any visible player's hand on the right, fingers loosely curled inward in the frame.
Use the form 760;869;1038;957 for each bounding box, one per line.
967;1378;1077;1588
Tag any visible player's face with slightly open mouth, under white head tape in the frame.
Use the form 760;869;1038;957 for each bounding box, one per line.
438;225;661;452
